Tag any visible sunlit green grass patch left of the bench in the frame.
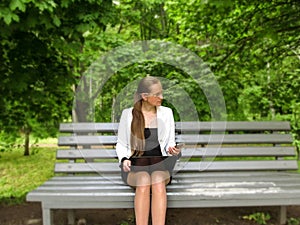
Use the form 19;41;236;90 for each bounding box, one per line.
0;147;56;204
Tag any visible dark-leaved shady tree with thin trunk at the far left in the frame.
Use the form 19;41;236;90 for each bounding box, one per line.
0;0;117;155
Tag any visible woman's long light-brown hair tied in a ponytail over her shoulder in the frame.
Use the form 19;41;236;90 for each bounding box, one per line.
130;76;160;156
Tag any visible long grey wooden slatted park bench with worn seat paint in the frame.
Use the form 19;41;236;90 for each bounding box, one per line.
27;122;300;225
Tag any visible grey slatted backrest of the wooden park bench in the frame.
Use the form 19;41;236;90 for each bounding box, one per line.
55;121;298;174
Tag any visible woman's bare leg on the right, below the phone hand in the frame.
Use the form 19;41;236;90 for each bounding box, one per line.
151;171;170;225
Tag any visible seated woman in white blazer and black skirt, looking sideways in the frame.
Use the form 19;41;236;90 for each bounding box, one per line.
116;76;180;225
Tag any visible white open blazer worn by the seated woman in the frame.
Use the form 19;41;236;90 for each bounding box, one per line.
116;106;175;163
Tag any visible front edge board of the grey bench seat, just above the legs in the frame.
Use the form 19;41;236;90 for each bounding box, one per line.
27;191;300;209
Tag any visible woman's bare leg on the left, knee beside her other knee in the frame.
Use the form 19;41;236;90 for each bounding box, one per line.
127;171;151;225
